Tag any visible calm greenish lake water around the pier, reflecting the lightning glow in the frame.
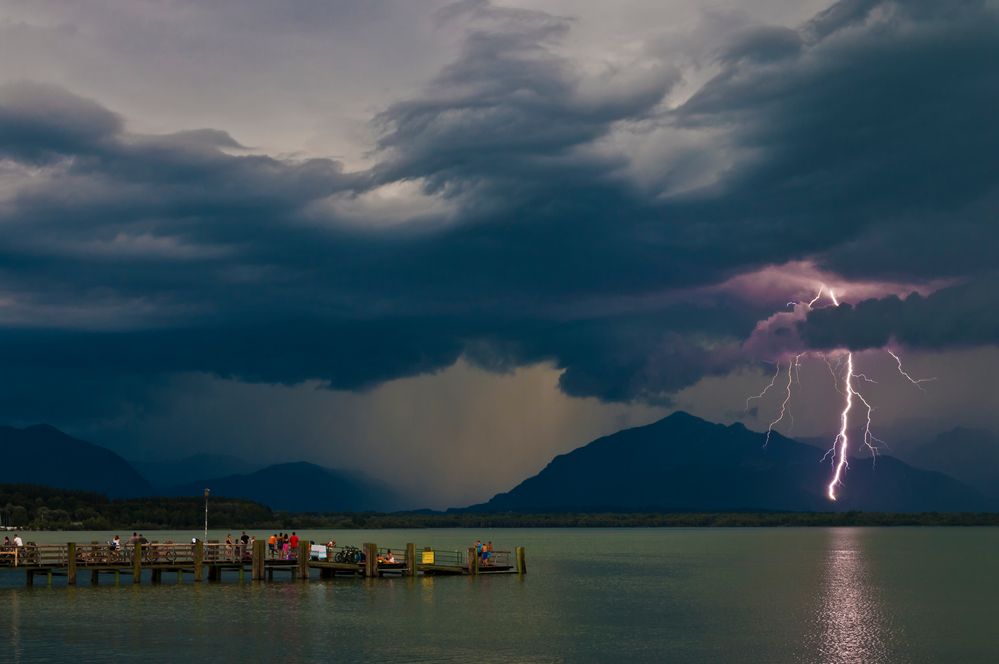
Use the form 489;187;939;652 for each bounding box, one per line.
0;528;999;664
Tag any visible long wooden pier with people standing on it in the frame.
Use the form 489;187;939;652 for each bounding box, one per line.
0;540;527;586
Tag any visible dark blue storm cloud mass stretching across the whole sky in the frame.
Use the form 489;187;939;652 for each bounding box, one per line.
0;2;999;416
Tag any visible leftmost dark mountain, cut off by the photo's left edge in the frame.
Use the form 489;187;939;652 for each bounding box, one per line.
0;424;153;498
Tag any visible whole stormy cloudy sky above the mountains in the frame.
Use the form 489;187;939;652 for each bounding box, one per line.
0;0;999;506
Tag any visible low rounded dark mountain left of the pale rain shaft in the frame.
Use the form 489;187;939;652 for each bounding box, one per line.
169;461;401;512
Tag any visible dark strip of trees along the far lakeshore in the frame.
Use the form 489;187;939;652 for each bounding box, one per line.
0;484;999;530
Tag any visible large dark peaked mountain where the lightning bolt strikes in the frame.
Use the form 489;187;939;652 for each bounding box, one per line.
468;412;984;512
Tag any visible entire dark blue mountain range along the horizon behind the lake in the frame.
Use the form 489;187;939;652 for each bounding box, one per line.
0;412;999;512
